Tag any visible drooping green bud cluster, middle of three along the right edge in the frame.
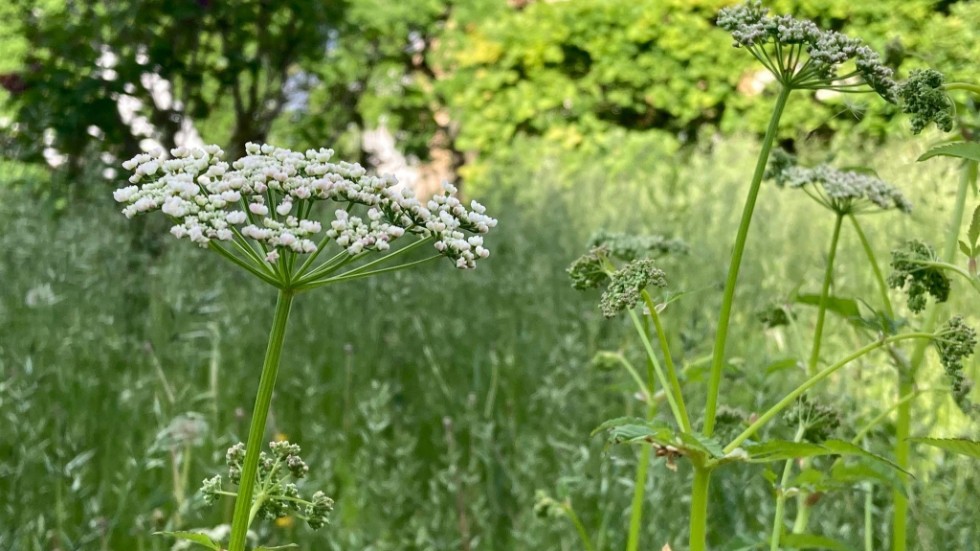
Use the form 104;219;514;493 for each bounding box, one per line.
888;240;950;313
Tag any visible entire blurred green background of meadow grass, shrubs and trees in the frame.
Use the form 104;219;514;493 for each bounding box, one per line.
0;0;980;551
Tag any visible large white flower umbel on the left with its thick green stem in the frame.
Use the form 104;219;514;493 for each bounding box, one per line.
114;144;497;551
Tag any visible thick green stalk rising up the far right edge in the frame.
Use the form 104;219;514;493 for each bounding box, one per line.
892;157;977;551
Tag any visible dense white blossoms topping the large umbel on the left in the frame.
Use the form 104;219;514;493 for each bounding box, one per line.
114;143;497;268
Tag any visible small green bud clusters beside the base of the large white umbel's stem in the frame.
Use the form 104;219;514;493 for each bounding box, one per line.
201;441;333;530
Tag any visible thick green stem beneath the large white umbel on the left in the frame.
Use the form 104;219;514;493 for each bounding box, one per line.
228;289;293;551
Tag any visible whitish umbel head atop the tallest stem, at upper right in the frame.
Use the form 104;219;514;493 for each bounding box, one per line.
718;0;897;99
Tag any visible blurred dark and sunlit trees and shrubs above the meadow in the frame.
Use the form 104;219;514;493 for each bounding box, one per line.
0;0;980;194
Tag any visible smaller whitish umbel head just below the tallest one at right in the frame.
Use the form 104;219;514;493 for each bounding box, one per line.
766;150;912;215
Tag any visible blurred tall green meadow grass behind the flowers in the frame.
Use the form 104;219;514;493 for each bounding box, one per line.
0;135;980;551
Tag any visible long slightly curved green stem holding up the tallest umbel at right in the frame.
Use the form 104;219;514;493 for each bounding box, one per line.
704;86;793;436
